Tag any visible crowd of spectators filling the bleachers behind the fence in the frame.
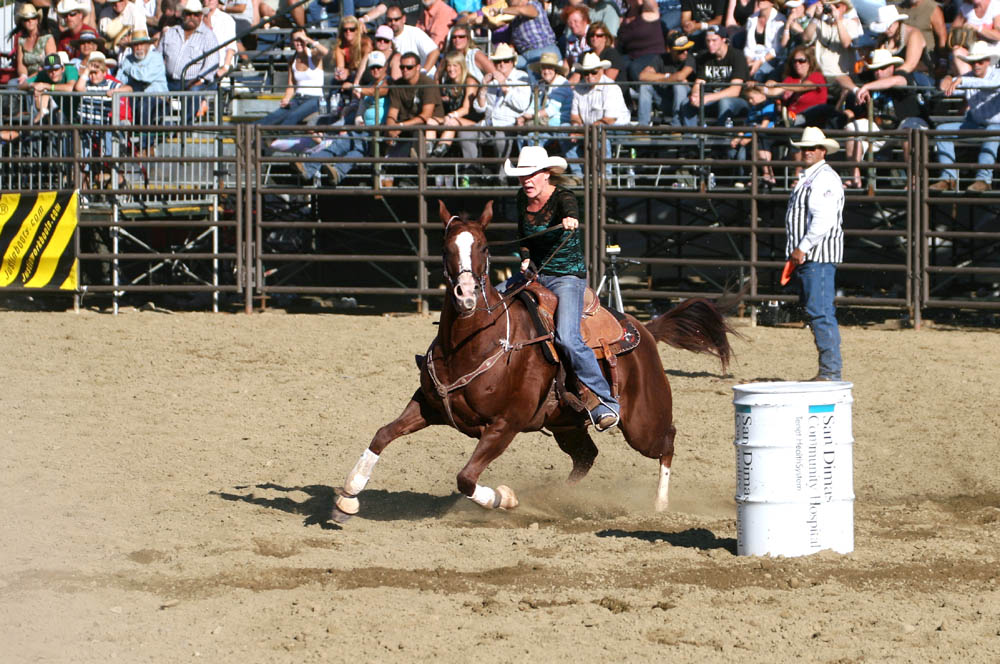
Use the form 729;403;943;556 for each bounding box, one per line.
0;0;1000;193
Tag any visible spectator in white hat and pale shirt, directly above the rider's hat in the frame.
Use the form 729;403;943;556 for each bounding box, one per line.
473;44;531;158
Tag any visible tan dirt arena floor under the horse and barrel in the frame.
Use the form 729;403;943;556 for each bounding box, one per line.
0;310;1000;663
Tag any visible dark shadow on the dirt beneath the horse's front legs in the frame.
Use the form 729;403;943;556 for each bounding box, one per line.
211;482;461;530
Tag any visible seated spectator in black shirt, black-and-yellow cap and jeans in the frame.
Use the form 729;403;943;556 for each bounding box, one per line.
638;31;696;127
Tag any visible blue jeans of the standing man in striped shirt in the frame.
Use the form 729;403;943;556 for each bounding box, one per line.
795;261;844;380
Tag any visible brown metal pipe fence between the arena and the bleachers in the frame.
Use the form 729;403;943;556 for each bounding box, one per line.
0;116;1000;323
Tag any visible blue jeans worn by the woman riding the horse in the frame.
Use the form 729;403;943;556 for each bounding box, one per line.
538;274;619;413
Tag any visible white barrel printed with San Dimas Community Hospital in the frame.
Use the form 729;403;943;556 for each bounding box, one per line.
733;381;854;556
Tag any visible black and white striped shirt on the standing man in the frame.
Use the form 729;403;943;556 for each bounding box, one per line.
785;161;844;263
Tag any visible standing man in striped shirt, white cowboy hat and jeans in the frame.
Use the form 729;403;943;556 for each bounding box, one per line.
785;127;844;380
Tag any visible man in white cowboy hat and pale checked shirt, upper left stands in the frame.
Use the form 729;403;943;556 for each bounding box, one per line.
159;0;219;90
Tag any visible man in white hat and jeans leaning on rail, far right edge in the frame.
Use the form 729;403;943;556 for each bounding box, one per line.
930;41;1000;194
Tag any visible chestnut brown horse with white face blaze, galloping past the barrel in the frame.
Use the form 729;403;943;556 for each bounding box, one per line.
332;202;732;522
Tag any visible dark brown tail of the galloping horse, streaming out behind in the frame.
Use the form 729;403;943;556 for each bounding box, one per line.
646;297;740;371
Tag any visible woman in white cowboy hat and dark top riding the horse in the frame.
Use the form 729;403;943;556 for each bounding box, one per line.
503;145;621;431
